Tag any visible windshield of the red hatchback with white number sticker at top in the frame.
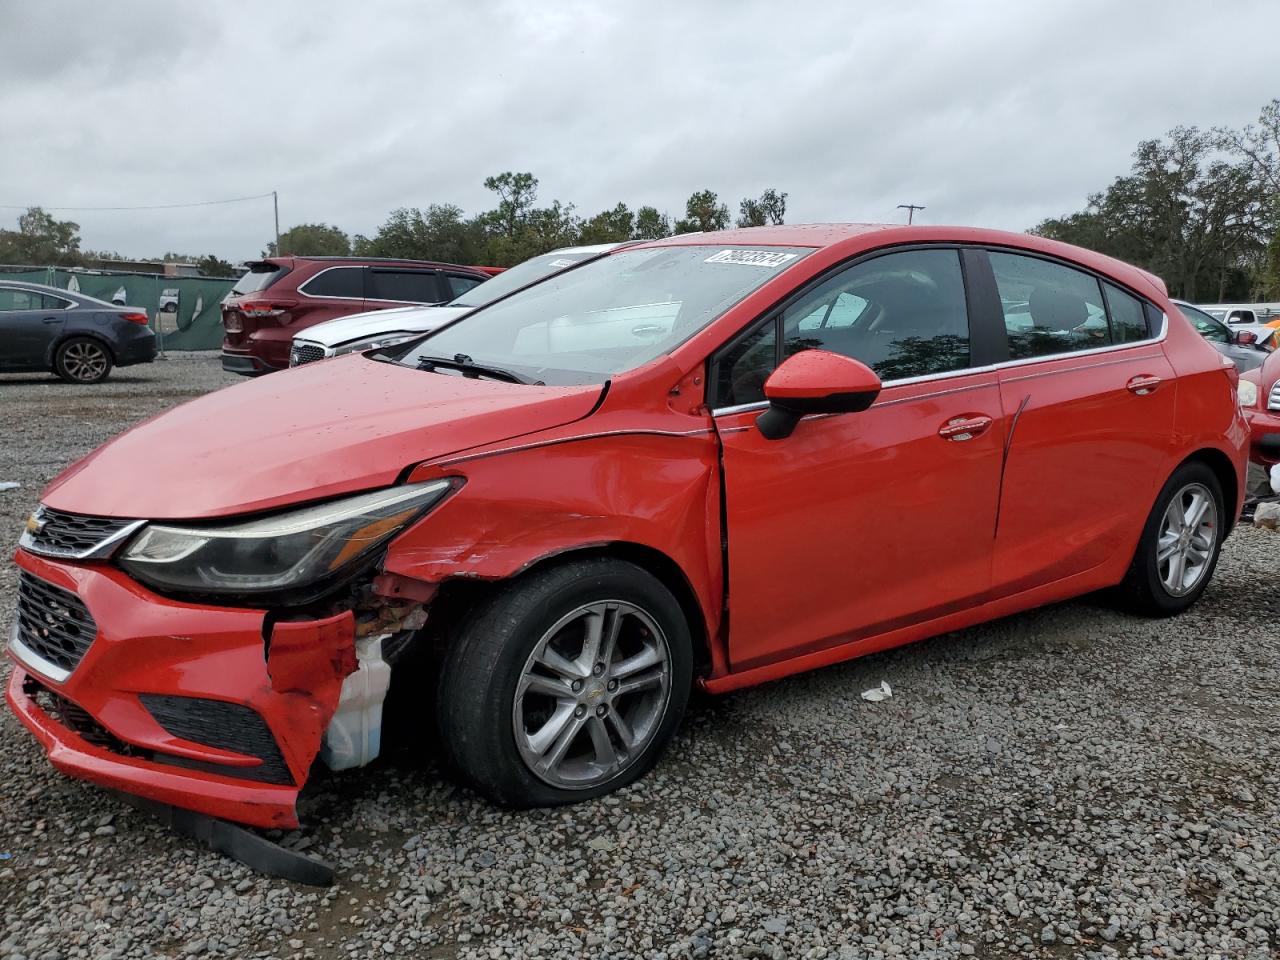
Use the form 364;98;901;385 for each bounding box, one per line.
399;246;813;385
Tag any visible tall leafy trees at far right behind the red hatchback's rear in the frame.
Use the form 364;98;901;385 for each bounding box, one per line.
1032;99;1280;303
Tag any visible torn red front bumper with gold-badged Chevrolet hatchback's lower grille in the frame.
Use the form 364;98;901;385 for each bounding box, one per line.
6;550;364;828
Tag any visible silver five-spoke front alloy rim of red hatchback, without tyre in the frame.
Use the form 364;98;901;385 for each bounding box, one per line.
512;600;671;790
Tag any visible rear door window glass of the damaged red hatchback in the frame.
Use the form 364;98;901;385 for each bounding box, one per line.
989;252;1111;360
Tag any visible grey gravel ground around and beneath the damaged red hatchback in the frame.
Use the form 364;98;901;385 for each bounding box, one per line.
0;356;1280;960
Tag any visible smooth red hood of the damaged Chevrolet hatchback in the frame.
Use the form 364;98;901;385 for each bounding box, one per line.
42;353;600;520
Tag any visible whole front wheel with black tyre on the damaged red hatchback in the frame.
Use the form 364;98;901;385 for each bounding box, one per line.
436;558;692;806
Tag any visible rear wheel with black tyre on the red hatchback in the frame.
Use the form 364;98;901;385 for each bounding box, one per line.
1120;463;1226;617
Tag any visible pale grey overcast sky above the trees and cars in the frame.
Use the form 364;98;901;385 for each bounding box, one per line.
0;0;1280;260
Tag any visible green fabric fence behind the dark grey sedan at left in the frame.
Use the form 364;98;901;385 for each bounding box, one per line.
0;268;236;349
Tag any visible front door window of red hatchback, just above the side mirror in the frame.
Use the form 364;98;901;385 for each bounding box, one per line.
716;250;969;407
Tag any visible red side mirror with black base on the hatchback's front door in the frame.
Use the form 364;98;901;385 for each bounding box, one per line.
755;349;881;440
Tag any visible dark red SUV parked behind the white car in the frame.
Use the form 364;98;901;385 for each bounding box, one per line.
223;257;490;376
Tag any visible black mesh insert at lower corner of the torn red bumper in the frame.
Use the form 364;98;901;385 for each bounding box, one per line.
138;694;293;783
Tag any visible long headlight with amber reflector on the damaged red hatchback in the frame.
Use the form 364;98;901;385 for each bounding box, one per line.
120;480;454;595
